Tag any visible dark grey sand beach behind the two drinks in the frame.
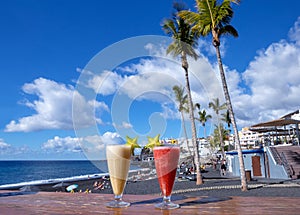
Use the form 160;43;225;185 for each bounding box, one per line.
7;168;300;197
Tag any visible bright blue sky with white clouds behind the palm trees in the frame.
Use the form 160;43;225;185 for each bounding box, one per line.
0;0;300;160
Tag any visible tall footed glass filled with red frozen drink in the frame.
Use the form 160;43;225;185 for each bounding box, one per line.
153;145;180;210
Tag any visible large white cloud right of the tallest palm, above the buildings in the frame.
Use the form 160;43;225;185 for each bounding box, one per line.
229;18;300;126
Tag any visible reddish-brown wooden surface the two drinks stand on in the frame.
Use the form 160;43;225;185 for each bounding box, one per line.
0;191;300;215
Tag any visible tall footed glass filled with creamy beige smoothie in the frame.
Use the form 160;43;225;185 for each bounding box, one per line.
106;145;131;208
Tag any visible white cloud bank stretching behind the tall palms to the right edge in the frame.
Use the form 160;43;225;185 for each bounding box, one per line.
79;17;300;131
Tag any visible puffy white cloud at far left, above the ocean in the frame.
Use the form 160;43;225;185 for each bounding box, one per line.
5;78;108;132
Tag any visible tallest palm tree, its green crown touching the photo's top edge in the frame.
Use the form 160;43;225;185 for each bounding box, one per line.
179;0;248;191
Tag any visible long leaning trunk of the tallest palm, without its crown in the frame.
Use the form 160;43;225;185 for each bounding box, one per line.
215;46;248;191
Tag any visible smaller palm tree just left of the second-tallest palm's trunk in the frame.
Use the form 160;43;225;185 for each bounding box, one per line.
173;85;192;155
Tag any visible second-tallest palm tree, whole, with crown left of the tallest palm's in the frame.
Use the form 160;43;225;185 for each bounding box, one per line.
163;3;203;185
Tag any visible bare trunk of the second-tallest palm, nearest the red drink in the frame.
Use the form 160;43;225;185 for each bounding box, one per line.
181;53;203;185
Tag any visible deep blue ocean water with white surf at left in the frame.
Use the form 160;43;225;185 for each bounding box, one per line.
0;160;107;188
